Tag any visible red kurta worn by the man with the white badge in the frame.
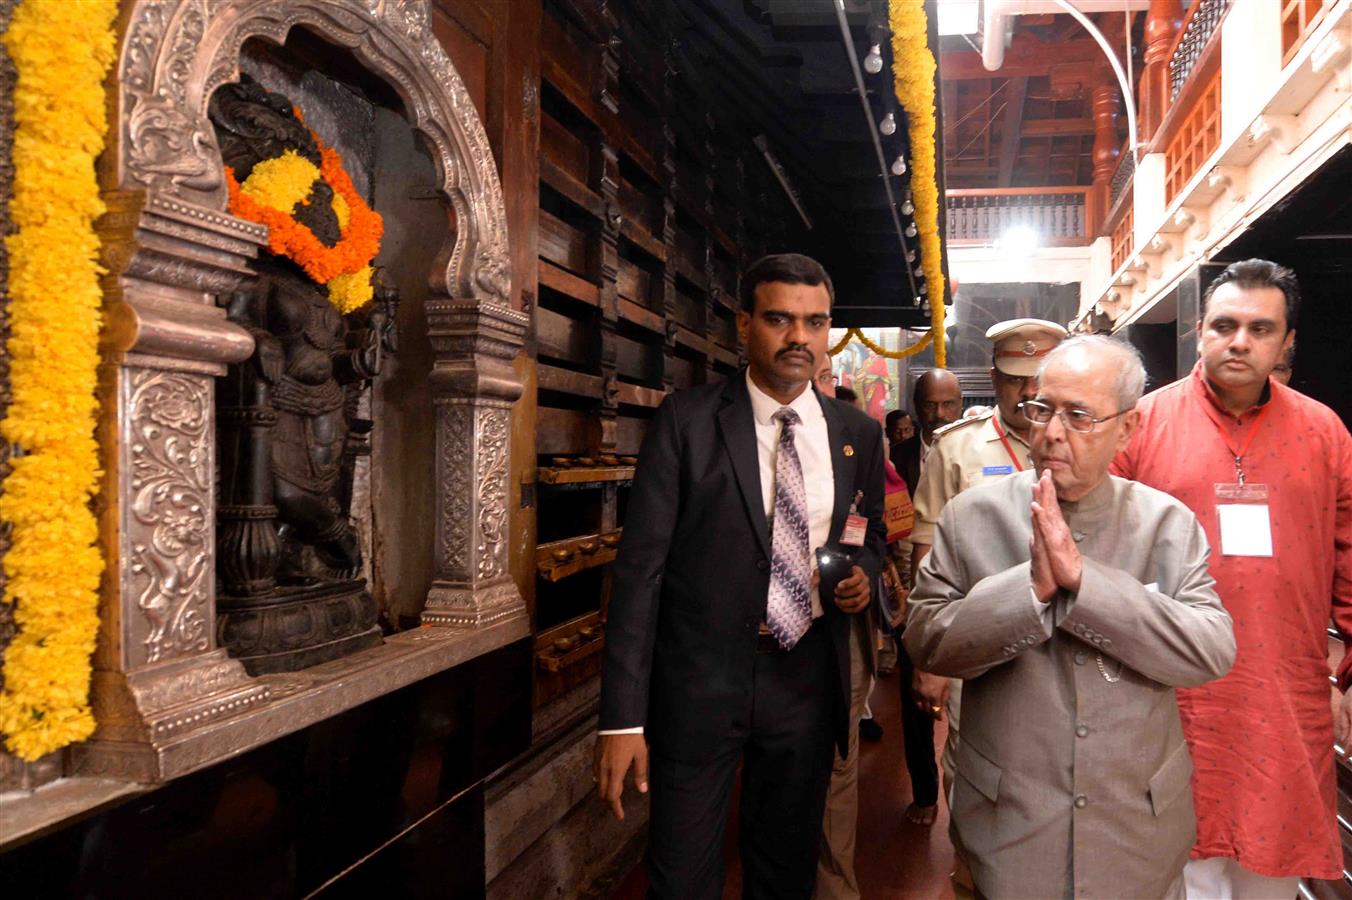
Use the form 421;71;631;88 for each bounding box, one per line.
1113;364;1352;878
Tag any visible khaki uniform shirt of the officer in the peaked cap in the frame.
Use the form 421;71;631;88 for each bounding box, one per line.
911;409;1033;545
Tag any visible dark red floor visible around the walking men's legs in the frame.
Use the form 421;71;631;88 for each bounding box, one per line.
611;659;953;900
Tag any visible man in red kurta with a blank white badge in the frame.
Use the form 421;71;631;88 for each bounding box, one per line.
1113;259;1352;897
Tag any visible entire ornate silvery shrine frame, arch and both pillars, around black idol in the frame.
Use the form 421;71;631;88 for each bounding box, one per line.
76;0;529;780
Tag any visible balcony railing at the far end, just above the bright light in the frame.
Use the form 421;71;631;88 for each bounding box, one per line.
948;185;1091;246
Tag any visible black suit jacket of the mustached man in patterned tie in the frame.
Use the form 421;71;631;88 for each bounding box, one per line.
600;369;887;762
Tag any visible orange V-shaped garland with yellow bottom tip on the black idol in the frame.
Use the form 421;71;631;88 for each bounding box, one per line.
226;122;385;314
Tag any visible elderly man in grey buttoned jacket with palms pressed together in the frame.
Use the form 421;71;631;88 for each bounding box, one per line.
904;338;1234;900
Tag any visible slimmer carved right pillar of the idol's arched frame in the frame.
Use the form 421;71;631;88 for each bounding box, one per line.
422;300;530;628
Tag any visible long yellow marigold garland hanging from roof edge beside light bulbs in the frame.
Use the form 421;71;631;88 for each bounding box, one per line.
888;0;948;366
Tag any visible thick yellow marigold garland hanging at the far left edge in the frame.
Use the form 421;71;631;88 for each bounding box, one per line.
0;0;118;759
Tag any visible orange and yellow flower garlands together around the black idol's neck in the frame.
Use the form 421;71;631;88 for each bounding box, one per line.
226;116;385;314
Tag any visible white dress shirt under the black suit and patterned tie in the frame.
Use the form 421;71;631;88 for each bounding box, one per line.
598;369;836;734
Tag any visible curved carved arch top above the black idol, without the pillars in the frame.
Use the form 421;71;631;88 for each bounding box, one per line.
110;0;510;305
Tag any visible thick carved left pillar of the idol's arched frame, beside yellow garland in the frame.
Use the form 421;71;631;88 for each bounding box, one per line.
73;189;269;781
